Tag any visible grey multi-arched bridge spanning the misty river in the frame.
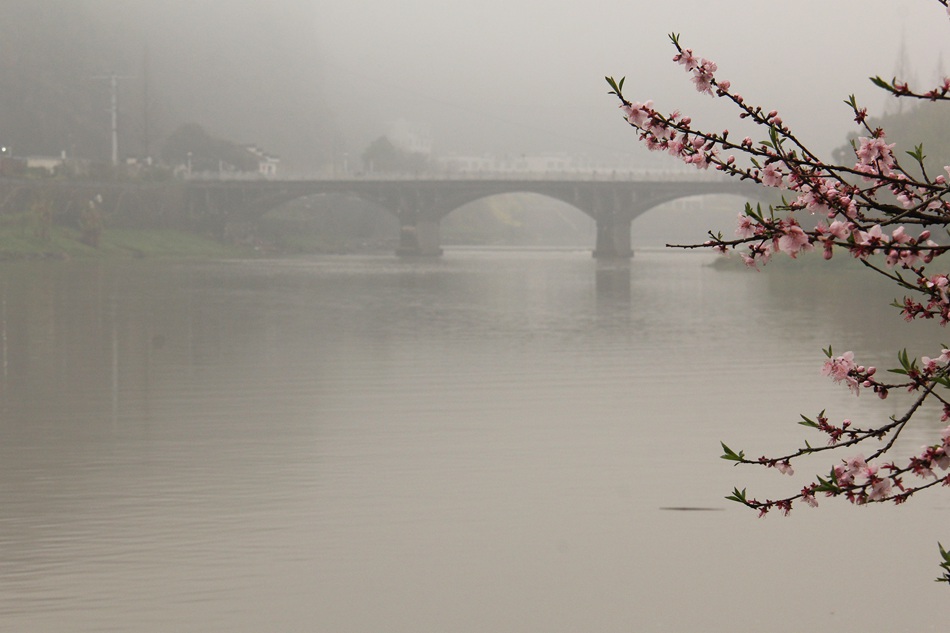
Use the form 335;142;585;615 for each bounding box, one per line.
180;175;762;258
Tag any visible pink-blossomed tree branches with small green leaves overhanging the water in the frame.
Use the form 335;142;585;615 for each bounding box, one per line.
606;0;950;583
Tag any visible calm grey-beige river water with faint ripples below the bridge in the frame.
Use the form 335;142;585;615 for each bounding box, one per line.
0;250;950;633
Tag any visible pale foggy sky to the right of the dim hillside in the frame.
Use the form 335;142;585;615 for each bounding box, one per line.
312;0;950;167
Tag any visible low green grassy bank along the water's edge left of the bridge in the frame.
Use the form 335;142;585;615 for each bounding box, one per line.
0;226;253;261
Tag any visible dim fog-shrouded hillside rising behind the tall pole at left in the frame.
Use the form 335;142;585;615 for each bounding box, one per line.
0;0;333;171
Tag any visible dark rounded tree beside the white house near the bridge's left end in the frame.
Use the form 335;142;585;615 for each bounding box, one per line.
162;123;258;172
